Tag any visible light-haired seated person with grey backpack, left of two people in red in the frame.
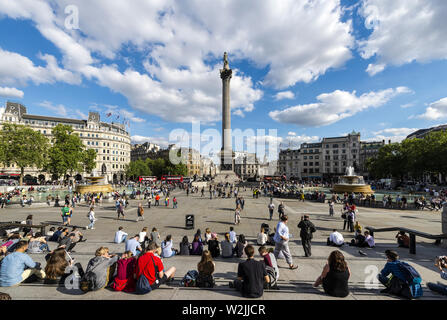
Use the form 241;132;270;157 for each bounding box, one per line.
80;247;119;292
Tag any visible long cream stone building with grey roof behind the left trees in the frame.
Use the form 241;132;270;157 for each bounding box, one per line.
0;102;131;182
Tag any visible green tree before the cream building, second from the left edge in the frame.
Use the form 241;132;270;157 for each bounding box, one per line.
46;124;96;181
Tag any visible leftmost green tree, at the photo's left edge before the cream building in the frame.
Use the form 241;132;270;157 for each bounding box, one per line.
0;123;49;185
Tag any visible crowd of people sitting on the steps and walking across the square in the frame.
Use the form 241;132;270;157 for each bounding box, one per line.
0;184;447;298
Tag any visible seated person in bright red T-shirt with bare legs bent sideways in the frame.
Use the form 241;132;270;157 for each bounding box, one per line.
136;242;176;294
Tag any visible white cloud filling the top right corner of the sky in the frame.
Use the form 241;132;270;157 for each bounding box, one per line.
358;0;447;75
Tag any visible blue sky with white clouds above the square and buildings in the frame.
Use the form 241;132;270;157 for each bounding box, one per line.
0;0;447;158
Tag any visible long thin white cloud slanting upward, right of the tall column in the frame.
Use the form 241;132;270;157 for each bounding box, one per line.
269;87;411;127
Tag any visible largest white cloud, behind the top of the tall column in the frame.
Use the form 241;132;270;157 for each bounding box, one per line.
0;0;354;122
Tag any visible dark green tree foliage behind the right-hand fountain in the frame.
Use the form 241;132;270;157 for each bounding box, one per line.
367;131;447;180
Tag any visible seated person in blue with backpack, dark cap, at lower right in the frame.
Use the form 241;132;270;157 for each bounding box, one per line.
377;250;422;299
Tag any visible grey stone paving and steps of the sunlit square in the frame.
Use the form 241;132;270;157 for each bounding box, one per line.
0;189;446;300
